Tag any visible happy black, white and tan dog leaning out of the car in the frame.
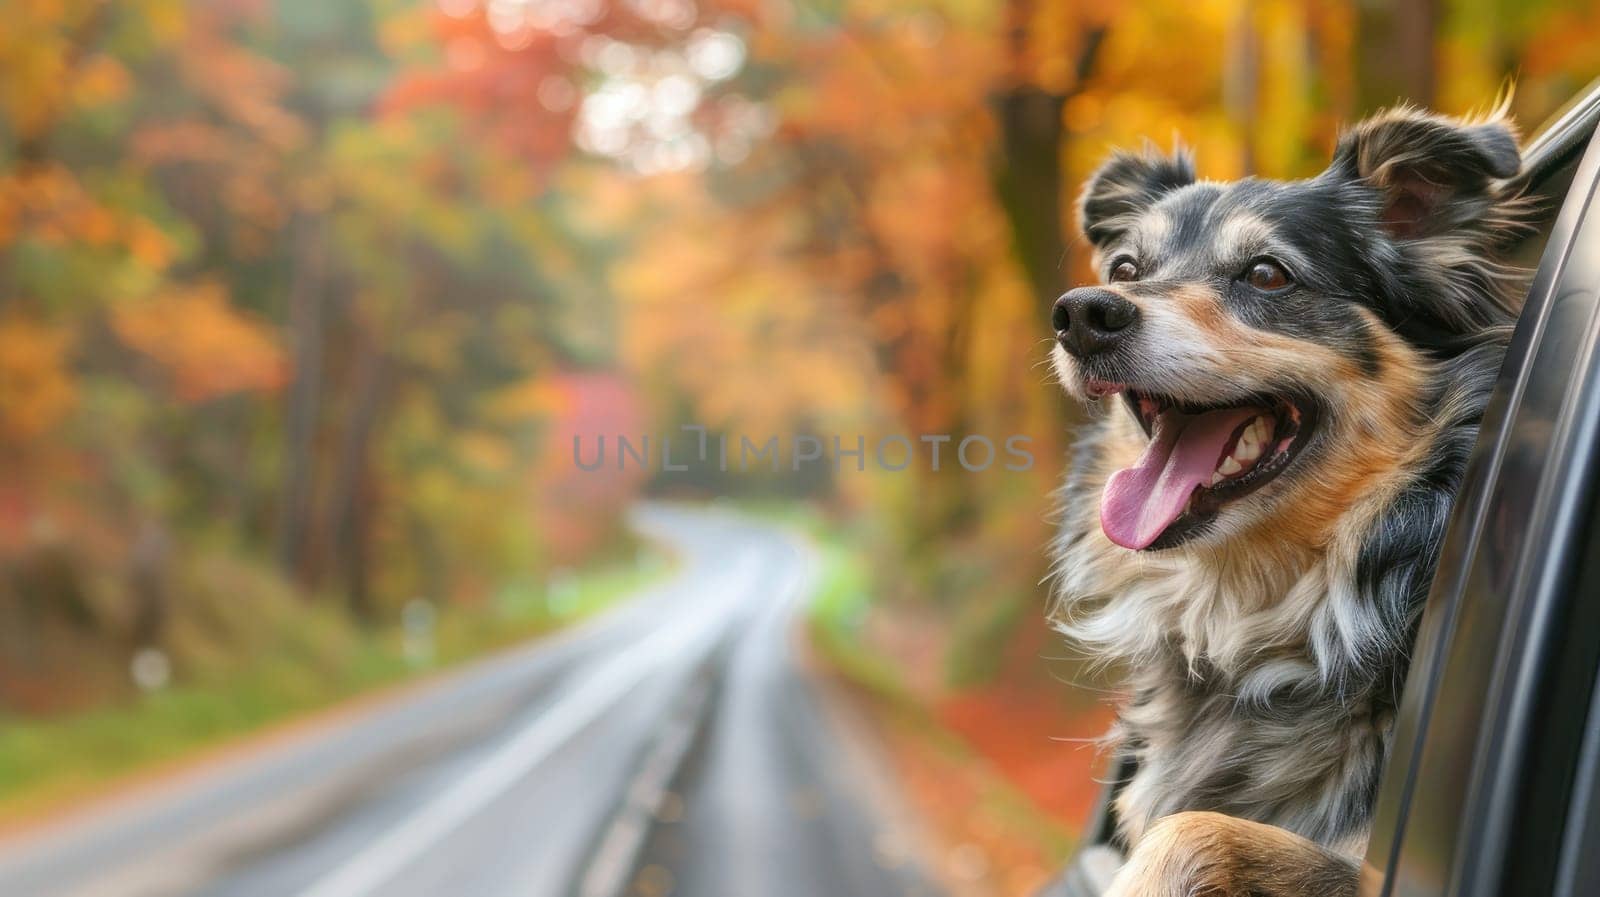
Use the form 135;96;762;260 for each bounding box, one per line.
1051;104;1526;897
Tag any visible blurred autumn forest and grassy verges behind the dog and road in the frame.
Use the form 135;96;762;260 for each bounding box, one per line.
0;0;1600;894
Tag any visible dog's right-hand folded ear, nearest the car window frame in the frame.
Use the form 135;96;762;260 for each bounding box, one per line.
1328;109;1522;240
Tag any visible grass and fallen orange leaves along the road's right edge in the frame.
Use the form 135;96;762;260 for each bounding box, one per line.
797;513;1075;892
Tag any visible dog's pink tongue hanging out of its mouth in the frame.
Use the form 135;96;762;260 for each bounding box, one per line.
1101;408;1261;550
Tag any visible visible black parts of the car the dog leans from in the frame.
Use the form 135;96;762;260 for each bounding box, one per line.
1040;85;1600;897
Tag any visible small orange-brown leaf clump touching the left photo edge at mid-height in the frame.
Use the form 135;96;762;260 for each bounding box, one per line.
0;313;77;448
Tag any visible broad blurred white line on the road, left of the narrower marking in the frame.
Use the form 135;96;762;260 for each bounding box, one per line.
299;555;768;897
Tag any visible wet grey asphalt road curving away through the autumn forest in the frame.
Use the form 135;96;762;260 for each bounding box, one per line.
0;505;936;897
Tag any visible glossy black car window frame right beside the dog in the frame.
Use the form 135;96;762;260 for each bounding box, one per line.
1362;90;1600;897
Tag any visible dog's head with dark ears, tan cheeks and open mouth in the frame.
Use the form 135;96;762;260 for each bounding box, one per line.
1053;110;1520;550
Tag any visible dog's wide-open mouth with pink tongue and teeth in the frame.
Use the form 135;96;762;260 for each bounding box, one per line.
1101;390;1317;550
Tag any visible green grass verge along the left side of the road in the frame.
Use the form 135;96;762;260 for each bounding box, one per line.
0;552;670;825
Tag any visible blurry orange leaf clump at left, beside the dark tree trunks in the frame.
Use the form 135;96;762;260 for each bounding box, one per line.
110;283;288;403
